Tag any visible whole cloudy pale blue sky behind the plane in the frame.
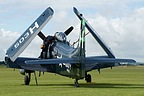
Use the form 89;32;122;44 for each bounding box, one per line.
0;0;144;62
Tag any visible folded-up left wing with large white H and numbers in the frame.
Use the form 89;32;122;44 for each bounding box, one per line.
6;7;54;61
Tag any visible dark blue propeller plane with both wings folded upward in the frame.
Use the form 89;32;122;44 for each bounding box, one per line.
5;7;135;87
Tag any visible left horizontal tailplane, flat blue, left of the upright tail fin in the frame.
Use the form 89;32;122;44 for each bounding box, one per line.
25;58;79;64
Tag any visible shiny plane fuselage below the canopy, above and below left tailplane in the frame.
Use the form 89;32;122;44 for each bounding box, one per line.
53;41;82;79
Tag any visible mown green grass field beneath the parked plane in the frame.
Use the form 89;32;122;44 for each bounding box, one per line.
0;67;144;96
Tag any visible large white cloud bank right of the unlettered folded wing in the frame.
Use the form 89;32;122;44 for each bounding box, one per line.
82;8;144;61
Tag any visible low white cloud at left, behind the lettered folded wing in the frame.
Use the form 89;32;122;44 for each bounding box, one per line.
0;29;42;60
